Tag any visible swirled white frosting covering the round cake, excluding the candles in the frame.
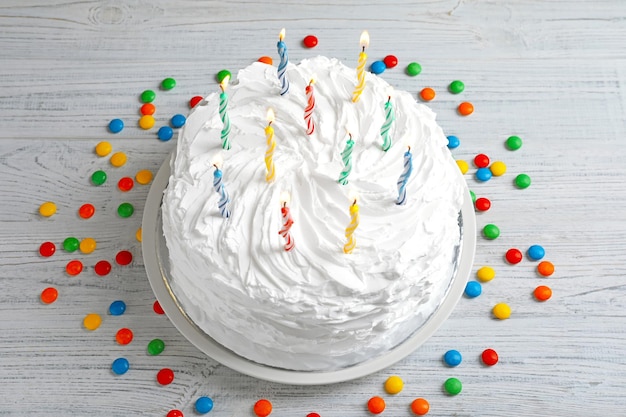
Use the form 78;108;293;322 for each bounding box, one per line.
163;57;463;370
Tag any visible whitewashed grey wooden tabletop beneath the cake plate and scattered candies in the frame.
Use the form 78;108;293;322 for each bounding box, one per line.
0;0;626;417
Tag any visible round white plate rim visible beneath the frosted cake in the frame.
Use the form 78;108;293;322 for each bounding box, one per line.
142;153;476;385
